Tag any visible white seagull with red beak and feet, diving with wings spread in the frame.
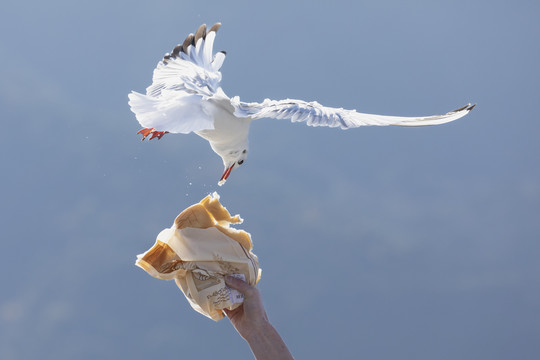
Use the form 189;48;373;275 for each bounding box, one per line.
128;23;475;186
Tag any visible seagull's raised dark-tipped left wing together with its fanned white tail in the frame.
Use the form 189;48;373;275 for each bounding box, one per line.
128;23;225;134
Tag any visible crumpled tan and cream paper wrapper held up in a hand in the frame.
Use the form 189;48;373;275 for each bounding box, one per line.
135;193;260;321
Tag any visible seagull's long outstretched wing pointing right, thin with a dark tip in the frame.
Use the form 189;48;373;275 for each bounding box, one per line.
231;96;475;129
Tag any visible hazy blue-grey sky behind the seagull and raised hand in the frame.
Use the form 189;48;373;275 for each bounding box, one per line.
0;0;540;360
